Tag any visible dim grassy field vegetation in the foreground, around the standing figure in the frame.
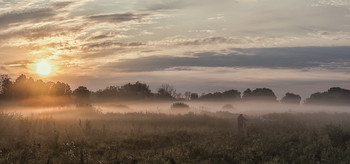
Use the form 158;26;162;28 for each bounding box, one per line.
0;107;350;164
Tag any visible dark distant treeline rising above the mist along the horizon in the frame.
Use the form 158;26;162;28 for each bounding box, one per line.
0;75;350;105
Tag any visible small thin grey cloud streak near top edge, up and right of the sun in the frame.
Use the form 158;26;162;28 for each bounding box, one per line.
88;13;149;23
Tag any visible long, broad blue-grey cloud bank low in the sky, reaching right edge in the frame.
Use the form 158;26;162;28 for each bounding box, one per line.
103;47;350;72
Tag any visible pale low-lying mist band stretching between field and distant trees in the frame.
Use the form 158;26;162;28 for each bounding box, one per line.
0;101;349;117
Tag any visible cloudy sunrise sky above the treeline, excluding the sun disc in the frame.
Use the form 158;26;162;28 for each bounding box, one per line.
0;0;350;98
